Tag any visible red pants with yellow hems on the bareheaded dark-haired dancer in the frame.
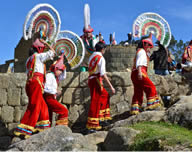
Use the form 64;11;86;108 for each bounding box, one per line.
86;77;111;130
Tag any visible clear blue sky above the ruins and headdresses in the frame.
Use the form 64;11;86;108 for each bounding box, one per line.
0;0;192;64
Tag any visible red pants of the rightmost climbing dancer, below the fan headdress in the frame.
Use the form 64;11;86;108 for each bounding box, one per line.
131;67;160;114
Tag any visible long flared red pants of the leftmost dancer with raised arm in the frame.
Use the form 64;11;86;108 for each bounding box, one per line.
14;73;50;138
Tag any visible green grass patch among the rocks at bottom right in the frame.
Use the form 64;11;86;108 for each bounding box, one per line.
129;122;192;150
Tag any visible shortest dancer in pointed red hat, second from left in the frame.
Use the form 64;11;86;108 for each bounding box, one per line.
43;55;68;126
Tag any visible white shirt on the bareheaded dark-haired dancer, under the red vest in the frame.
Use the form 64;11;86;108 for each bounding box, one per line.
88;52;106;76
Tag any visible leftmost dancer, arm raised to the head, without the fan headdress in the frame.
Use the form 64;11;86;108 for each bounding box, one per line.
14;38;55;138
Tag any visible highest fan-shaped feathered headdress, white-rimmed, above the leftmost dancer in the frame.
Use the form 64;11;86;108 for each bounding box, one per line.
23;4;61;42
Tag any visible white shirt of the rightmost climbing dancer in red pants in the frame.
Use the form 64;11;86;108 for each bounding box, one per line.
136;49;147;68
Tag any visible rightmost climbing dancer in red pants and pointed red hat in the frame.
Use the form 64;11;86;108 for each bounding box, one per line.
131;34;160;114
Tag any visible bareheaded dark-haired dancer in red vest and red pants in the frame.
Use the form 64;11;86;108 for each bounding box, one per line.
86;42;115;133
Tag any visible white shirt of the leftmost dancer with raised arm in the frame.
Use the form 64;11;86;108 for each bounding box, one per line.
26;50;54;74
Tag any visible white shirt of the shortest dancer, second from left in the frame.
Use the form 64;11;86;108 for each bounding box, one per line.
44;70;66;95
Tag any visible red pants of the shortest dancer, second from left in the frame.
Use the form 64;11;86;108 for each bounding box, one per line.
43;93;68;126
